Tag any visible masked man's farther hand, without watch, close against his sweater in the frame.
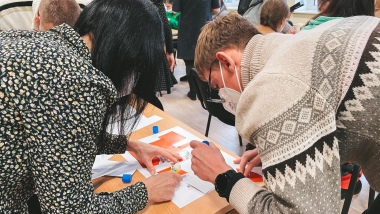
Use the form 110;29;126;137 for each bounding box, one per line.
234;149;261;177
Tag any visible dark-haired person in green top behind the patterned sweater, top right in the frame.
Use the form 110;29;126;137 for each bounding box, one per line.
302;0;375;30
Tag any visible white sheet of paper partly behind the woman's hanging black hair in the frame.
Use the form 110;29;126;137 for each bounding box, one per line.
107;108;163;135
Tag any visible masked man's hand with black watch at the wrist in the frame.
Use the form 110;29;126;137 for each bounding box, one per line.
190;140;232;183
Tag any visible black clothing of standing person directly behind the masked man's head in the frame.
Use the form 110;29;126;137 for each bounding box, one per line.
173;0;220;60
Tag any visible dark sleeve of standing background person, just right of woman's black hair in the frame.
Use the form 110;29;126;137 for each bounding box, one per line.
151;0;174;53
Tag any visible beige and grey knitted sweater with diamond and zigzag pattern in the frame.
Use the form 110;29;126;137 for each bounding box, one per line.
229;17;380;214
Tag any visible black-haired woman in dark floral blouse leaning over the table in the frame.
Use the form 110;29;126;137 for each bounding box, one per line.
0;0;182;213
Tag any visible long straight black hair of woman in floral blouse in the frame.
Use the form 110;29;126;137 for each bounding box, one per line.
74;0;165;147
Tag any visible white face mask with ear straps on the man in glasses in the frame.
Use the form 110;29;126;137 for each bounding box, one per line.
219;57;243;115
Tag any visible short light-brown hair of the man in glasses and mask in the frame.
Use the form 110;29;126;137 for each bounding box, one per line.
194;13;260;81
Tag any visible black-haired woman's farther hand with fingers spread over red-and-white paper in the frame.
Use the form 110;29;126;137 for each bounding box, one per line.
127;139;182;175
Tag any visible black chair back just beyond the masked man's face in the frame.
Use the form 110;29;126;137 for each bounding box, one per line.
190;68;235;126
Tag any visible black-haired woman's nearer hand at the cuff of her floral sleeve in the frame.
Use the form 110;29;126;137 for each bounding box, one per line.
143;171;183;202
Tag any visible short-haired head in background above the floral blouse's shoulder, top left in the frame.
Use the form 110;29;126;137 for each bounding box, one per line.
34;0;82;31
